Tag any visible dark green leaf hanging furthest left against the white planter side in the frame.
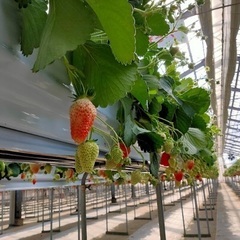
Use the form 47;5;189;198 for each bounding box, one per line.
21;0;47;56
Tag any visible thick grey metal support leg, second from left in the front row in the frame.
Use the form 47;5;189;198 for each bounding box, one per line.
156;181;166;240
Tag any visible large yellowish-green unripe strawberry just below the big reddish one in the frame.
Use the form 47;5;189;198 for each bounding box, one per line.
77;141;99;173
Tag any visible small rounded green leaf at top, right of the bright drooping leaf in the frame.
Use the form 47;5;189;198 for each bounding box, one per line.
147;12;169;36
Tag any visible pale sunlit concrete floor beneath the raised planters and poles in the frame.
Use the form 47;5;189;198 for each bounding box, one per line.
0;183;240;240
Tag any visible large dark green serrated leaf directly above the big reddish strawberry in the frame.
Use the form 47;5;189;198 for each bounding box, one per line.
73;42;137;107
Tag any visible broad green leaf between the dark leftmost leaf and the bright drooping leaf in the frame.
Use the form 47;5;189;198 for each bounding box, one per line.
33;0;94;72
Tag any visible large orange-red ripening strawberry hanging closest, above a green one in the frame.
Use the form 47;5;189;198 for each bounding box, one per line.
70;97;97;144
